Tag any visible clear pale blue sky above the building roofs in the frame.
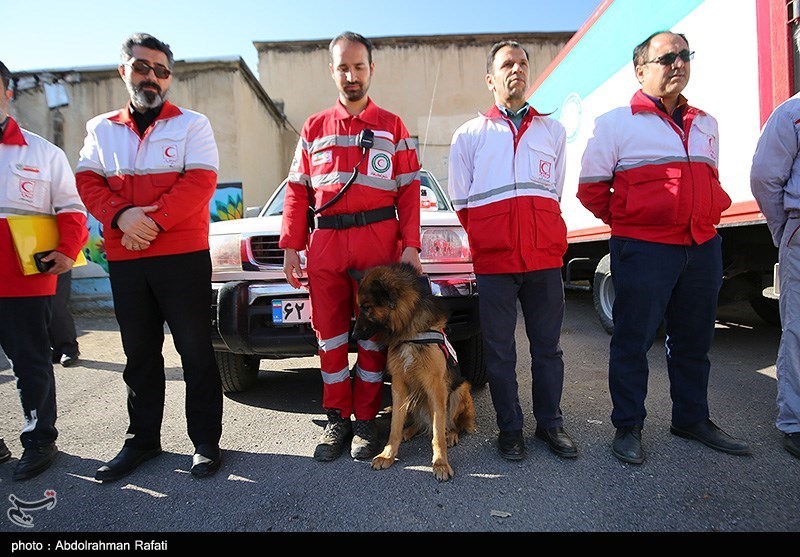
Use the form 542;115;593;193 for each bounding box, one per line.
0;0;601;75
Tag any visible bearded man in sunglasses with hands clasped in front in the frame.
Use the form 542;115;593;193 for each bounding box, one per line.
76;33;222;482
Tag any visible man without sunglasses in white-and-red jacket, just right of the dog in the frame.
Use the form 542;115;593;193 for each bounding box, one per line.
448;41;578;460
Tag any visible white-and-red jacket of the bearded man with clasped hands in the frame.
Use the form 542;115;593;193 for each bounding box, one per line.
76;102;219;261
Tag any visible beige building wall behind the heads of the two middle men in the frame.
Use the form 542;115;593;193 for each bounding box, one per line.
254;32;573;183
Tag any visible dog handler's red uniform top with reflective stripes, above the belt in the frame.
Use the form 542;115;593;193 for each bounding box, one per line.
279;100;421;250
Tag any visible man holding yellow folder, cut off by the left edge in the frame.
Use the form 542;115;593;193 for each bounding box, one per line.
0;62;89;480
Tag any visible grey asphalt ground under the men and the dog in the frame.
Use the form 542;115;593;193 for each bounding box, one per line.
0;291;800;551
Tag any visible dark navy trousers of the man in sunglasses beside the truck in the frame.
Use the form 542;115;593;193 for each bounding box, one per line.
608;236;722;428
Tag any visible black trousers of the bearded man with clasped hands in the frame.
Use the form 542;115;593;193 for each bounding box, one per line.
108;251;222;449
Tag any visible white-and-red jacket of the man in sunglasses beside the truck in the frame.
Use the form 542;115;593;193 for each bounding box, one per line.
578;91;731;245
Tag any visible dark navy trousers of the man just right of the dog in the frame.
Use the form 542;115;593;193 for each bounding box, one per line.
476;269;564;431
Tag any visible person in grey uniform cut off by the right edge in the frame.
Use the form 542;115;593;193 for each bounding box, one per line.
750;27;800;458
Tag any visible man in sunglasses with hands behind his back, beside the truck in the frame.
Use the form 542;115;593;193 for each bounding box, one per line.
578;31;750;464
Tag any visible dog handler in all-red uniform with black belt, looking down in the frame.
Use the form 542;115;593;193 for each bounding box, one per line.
280;32;422;461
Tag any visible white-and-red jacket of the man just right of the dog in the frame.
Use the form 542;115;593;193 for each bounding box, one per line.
447;106;567;274
